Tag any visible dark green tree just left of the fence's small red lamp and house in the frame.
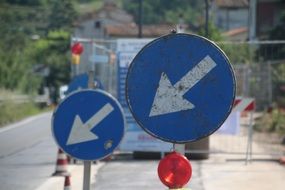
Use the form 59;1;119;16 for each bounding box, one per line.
44;0;78;99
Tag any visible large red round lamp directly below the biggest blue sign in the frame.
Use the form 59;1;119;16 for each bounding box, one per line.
157;152;192;189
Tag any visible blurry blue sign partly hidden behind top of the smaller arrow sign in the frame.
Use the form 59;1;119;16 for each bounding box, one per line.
66;73;103;94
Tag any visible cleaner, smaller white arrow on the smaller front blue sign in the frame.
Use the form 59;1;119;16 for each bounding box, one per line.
66;103;114;145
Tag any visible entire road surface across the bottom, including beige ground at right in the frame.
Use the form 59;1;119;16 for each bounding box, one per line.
0;113;285;190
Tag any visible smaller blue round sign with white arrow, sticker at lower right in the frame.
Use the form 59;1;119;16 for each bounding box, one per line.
52;89;125;160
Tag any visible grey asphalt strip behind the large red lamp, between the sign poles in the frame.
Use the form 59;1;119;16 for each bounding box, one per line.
91;155;204;190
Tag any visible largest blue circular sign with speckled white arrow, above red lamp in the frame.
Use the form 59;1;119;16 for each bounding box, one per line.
126;33;236;143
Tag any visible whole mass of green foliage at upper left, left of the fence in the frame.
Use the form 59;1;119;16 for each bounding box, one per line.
0;0;77;96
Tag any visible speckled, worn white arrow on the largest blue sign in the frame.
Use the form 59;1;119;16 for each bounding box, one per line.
149;55;217;117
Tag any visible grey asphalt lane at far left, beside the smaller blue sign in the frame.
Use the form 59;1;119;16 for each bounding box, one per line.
0;113;57;190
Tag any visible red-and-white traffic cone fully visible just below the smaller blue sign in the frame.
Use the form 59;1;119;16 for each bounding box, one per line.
52;149;70;176
